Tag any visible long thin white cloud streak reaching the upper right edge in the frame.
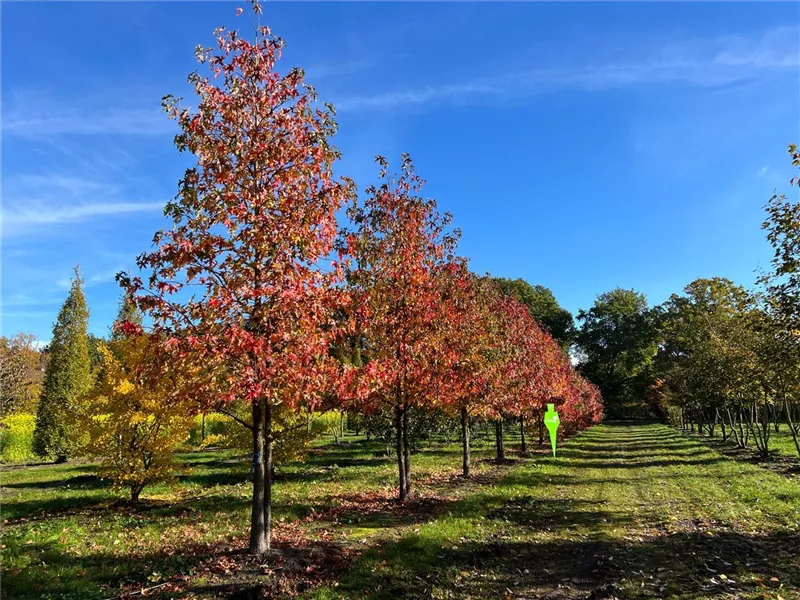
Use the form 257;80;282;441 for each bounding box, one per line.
335;27;800;111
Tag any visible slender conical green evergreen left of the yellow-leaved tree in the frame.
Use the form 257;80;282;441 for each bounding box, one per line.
33;268;91;460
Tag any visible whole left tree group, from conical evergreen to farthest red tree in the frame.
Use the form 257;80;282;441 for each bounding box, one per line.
4;2;602;554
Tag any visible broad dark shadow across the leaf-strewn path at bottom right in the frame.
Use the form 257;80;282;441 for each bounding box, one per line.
330;531;800;600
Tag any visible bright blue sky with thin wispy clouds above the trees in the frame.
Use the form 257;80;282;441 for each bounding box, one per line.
0;0;800;340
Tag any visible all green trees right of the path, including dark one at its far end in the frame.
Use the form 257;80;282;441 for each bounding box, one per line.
575;145;800;456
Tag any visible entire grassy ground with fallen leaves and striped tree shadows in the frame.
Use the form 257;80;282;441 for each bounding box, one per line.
0;424;800;600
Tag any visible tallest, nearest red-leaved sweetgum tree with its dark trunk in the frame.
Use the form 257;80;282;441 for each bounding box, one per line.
120;2;352;555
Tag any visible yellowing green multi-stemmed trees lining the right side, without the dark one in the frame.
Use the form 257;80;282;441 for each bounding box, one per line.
657;145;800;456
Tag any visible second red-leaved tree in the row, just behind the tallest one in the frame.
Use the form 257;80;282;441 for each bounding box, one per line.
340;155;458;501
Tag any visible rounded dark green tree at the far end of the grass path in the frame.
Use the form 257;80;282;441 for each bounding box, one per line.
576;288;658;418
